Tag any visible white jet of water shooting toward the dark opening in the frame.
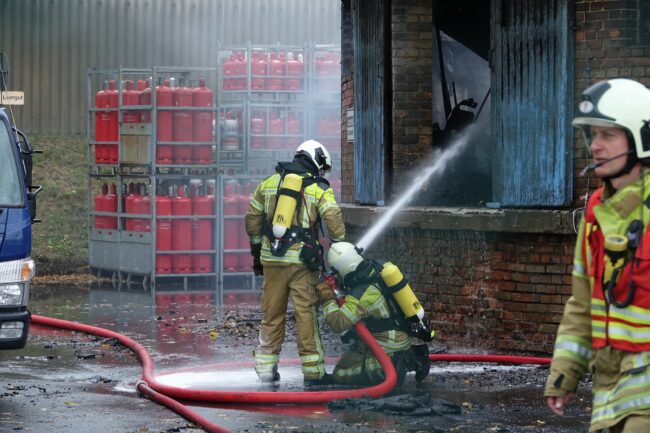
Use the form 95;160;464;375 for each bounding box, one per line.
356;127;474;250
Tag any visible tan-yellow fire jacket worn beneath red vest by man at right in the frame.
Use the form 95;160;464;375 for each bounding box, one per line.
544;176;650;431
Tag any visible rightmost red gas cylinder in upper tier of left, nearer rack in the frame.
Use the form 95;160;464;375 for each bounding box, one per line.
192;78;213;165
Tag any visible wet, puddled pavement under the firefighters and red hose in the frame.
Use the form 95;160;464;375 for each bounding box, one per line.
0;286;590;433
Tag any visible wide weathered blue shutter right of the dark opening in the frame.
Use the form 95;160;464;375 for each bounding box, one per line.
491;0;573;206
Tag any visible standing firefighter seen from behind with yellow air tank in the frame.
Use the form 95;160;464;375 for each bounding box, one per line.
246;140;345;384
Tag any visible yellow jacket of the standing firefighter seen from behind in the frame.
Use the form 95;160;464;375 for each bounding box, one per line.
245;167;345;266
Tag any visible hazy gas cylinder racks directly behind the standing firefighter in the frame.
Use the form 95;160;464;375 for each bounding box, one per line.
217;44;341;290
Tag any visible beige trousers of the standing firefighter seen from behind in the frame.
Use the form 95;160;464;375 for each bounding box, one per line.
255;264;325;379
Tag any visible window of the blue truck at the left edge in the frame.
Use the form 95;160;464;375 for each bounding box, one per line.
0;120;25;207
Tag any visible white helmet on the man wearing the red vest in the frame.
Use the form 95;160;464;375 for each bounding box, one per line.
572;78;650;159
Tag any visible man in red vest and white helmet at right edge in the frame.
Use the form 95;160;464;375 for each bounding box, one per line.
544;79;650;433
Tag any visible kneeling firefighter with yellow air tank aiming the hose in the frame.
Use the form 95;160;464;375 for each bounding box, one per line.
318;242;434;386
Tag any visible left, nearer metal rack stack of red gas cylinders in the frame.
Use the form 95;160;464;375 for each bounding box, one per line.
88;67;219;289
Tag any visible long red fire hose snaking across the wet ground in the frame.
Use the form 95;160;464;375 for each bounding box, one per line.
32;315;550;433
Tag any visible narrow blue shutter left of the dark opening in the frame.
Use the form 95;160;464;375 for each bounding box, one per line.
352;0;386;205
